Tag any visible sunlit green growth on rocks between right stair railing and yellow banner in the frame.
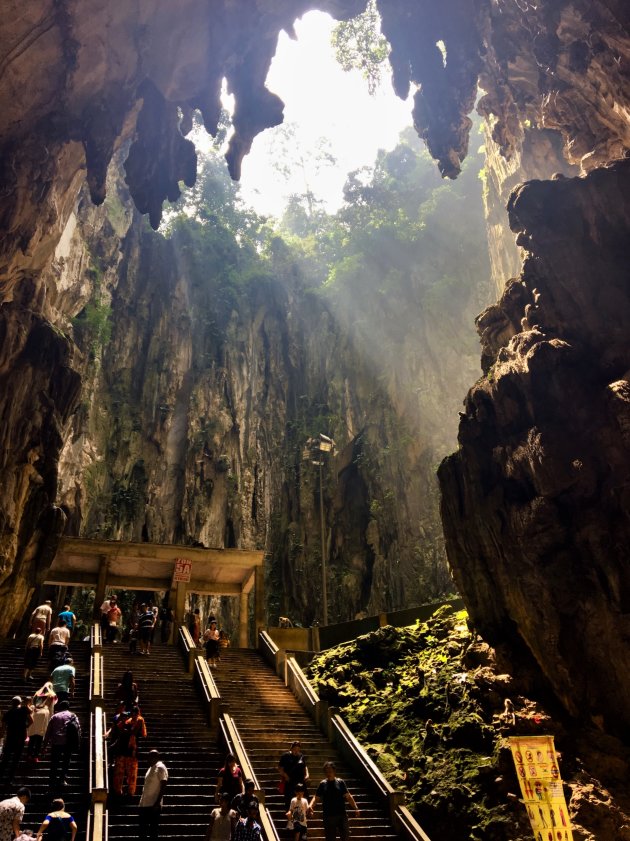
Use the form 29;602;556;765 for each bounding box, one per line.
308;608;531;841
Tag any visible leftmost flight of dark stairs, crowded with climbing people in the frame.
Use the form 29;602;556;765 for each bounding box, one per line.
0;640;90;839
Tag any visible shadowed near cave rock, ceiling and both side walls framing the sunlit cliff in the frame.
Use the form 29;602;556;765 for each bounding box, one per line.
0;0;630;740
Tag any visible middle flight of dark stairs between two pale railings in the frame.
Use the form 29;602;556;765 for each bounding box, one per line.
103;644;225;841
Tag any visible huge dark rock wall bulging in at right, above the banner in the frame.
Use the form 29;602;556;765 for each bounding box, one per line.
440;161;630;735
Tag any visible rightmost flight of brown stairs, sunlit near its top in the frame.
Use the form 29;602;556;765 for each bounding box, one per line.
213;649;398;841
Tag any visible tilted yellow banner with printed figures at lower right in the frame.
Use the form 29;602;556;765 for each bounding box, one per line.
509;736;573;841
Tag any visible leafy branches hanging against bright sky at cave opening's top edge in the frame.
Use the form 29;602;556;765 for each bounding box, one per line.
331;0;389;94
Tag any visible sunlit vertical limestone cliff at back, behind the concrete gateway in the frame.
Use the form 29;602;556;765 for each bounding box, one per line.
49;172;479;622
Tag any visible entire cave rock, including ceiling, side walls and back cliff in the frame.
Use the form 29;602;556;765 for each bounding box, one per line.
0;0;630;837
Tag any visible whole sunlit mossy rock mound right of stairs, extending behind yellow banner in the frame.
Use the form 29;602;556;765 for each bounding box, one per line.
309;608;630;841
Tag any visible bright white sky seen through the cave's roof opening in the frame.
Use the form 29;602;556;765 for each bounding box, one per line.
232;12;412;215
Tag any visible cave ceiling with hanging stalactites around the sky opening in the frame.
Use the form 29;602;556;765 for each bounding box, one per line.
0;0;630;291
